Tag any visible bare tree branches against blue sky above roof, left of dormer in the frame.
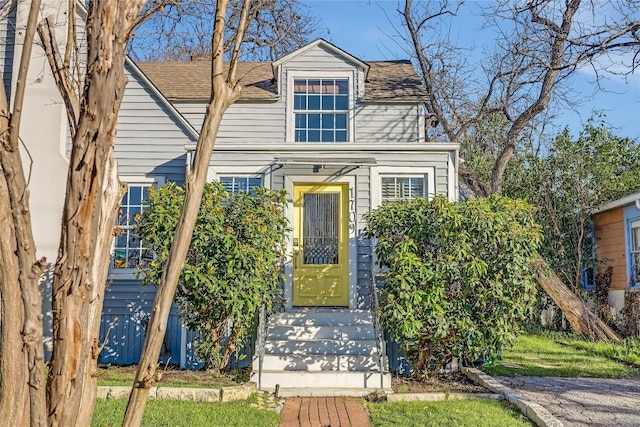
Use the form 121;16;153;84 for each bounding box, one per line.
129;0;319;61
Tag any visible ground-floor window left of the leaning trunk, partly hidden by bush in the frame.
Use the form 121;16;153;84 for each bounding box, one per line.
113;184;153;269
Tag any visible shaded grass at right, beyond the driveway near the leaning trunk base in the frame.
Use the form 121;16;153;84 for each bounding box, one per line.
483;334;640;378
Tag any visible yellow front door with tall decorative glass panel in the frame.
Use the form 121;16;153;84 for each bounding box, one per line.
293;184;349;307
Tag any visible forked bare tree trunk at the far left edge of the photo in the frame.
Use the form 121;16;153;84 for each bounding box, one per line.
0;0;46;426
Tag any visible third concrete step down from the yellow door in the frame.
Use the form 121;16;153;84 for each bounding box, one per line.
265;340;377;356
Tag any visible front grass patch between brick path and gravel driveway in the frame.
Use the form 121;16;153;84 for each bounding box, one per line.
369;400;533;427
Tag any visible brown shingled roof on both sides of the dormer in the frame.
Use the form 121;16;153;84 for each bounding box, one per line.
137;60;426;102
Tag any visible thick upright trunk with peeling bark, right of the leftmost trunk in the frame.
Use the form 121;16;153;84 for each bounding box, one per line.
47;0;146;426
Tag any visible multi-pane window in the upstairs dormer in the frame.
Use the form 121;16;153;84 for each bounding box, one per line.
293;79;349;142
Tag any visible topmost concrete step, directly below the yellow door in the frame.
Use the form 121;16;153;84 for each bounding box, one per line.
268;308;373;326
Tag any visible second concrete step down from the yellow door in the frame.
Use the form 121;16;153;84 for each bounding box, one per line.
267;325;376;341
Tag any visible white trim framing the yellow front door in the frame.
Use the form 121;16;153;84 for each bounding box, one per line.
284;175;358;310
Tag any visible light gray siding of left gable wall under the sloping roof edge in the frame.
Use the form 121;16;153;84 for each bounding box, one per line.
114;65;195;182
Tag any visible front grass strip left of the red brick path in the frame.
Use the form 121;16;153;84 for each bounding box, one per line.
91;399;280;427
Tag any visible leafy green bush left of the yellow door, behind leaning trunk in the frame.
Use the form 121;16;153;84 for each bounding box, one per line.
137;182;288;369
